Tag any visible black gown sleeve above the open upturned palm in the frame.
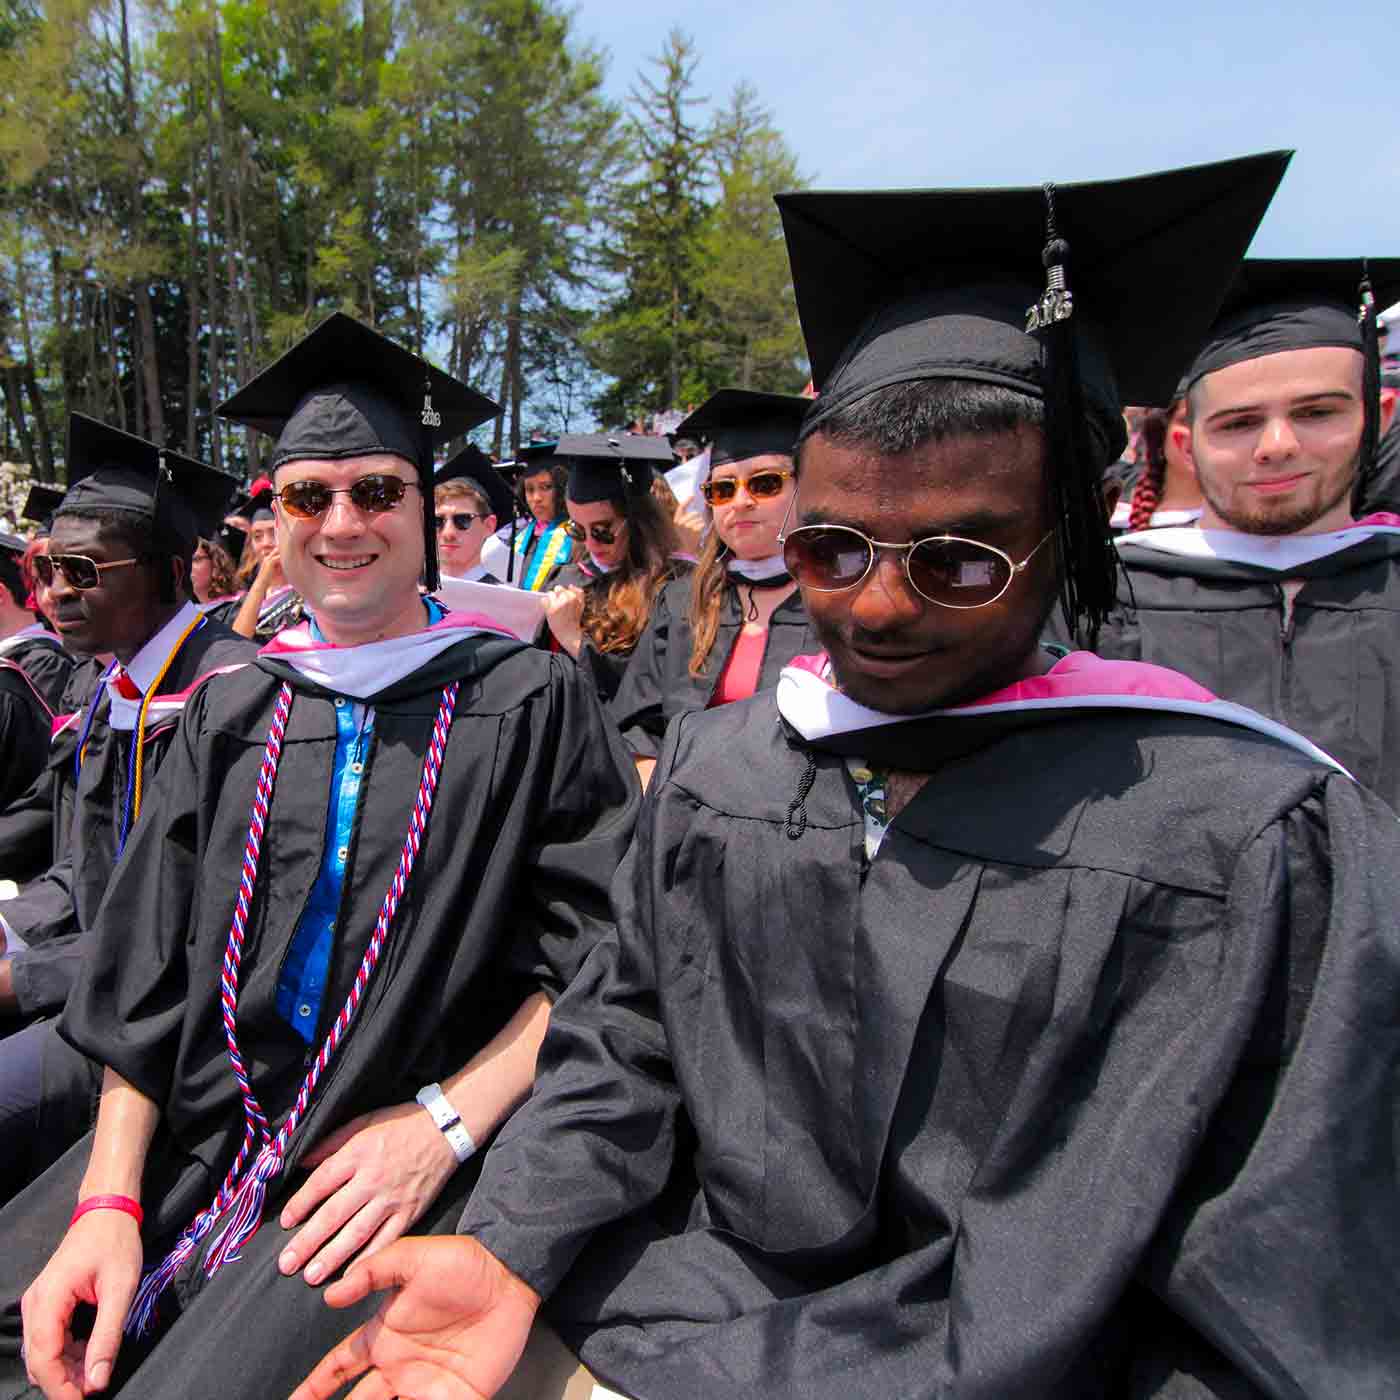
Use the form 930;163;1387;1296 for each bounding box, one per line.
459;716;680;1296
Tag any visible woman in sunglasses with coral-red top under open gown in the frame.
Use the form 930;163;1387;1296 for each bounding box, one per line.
610;389;815;783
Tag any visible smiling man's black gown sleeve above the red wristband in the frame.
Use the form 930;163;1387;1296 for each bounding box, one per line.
59;690;204;1103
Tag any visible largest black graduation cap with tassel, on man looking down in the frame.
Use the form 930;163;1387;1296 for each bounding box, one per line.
777;151;1291;633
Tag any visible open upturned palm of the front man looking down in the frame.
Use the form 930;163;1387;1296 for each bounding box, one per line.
291;1235;539;1400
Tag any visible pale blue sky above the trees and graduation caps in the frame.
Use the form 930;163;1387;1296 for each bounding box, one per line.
577;0;1400;258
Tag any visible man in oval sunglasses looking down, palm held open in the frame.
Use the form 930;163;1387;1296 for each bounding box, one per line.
295;157;1400;1400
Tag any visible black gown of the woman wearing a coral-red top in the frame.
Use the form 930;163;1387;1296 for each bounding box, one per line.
608;575;820;759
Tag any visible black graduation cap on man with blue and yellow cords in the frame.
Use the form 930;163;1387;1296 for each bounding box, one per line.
55;413;238;556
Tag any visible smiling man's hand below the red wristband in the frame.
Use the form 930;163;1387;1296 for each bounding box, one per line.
20;1210;141;1400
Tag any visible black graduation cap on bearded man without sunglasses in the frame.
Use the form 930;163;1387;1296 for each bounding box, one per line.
1186;258;1400;479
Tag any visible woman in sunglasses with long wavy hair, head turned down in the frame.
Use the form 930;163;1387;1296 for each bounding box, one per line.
545;434;689;700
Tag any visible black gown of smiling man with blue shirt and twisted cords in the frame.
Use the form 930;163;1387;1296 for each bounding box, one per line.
0;637;638;1400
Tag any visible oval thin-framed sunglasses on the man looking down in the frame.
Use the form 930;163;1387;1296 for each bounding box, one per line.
778;495;1054;608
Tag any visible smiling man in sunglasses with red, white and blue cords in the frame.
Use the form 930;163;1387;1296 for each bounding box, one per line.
0;315;637;1400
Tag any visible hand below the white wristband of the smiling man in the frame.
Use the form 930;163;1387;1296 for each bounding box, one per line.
277;1103;458;1284
